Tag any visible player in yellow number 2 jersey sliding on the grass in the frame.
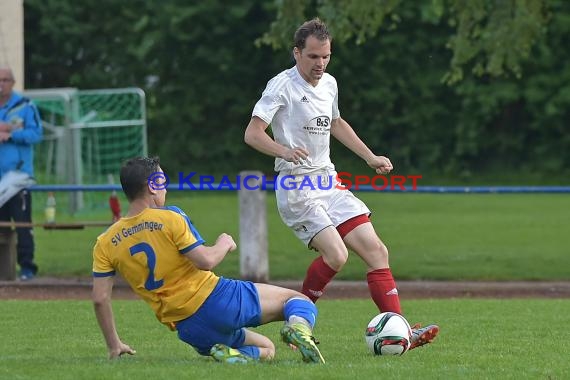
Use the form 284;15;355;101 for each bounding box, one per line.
92;157;324;363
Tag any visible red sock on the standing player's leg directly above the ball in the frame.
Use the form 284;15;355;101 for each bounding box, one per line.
366;268;402;314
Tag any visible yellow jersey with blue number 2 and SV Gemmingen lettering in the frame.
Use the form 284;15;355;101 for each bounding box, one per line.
93;206;219;324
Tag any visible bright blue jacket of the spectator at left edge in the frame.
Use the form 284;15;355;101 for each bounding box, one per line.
0;92;42;178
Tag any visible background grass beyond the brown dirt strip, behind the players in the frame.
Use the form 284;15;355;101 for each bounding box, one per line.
34;191;570;281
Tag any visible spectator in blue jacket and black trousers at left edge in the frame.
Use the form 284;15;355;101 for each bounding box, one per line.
0;67;42;281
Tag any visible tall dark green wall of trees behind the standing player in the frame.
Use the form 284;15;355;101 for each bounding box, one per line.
24;0;570;183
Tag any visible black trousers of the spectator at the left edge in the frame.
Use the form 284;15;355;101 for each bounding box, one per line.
0;190;38;274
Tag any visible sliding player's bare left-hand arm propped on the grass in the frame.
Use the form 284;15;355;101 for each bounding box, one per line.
91;276;136;359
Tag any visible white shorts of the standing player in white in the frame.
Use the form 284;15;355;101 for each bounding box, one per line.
275;172;370;247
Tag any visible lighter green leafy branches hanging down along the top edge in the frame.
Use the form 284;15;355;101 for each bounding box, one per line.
257;0;549;84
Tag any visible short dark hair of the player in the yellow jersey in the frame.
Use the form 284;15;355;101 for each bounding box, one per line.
121;157;160;201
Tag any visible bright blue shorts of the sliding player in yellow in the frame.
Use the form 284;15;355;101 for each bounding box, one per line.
176;277;261;355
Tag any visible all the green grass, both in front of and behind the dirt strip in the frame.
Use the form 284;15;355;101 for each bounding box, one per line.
5;192;570;380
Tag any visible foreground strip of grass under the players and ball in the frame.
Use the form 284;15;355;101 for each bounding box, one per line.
0;299;570;380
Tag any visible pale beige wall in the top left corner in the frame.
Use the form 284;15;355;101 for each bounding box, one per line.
0;0;24;91
